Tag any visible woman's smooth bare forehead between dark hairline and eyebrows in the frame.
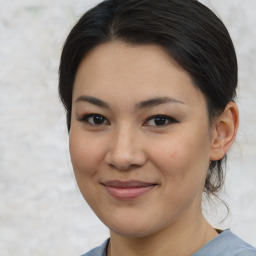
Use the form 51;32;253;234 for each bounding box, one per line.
74;42;207;108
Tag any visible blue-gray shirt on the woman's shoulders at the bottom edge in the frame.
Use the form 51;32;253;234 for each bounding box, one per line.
82;229;256;256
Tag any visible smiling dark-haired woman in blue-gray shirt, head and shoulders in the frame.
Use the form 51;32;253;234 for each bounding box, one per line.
59;0;256;256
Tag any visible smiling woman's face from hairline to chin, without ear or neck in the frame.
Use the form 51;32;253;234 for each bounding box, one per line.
70;42;216;237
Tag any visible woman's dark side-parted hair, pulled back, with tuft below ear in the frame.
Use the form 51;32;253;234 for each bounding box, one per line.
59;0;238;200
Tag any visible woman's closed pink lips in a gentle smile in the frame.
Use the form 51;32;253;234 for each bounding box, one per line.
103;180;156;200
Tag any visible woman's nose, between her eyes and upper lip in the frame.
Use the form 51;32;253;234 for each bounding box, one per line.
106;127;147;171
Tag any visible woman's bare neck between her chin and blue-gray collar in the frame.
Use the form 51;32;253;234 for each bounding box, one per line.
107;214;218;256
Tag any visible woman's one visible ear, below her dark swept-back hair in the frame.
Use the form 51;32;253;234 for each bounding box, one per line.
210;102;239;161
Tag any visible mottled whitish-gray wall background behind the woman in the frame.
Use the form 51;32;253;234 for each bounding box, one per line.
0;0;256;256
